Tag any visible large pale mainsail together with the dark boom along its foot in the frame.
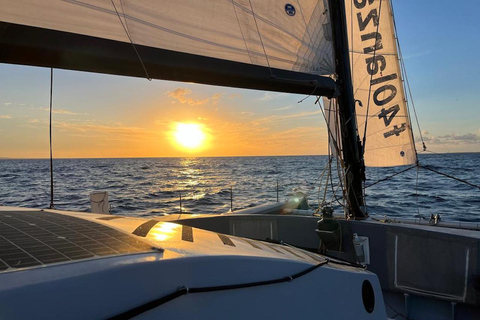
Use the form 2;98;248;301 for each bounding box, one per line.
0;0;336;96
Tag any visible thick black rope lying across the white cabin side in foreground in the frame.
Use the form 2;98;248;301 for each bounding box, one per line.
109;259;330;320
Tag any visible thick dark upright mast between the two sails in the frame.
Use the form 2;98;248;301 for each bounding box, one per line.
328;0;367;219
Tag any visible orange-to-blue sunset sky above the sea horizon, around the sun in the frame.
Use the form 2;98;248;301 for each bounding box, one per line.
0;0;480;158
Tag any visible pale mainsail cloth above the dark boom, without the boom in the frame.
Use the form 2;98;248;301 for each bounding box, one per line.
0;0;334;95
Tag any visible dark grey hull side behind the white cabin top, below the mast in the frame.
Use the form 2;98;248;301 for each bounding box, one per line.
172;205;480;319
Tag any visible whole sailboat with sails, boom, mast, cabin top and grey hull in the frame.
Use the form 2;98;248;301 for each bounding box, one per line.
0;0;480;319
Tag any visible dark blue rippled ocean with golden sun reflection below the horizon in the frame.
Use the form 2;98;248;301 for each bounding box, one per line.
0;153;480;222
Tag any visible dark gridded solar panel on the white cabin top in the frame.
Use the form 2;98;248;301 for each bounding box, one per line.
0;211;152;271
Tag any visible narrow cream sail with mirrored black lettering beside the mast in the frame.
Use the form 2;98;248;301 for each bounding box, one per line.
345;0;417;167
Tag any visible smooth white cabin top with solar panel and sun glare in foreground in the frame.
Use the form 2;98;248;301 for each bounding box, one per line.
0;207;386;319
